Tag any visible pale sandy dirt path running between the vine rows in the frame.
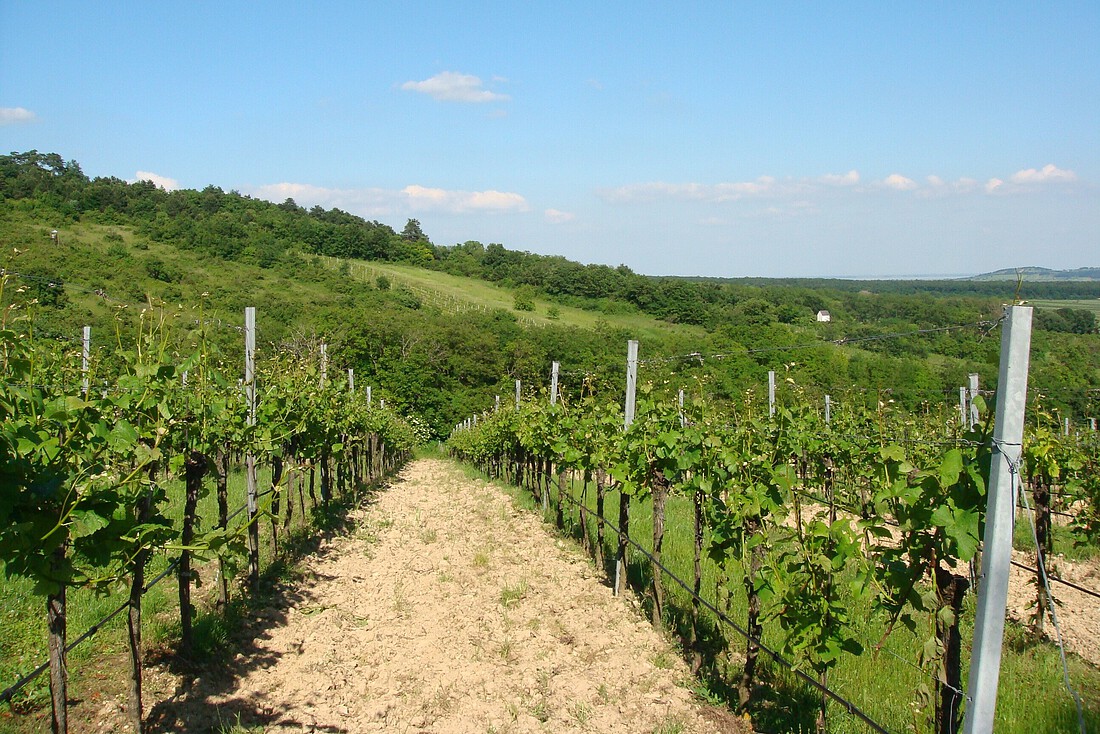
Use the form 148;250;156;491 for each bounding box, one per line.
128;460;748;734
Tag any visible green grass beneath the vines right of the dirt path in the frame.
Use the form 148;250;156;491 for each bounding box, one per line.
468;455;1100;734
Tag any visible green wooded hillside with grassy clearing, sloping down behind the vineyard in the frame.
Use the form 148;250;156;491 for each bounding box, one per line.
0;152;1100;426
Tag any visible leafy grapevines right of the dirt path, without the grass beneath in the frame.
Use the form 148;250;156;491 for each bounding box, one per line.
448;374;1100;733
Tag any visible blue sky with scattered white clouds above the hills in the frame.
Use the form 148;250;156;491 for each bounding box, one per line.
0;0;1100;277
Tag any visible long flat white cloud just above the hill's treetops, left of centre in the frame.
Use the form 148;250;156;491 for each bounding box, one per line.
250;183;528;218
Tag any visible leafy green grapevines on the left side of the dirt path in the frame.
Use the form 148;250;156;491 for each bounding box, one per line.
0;274;424;732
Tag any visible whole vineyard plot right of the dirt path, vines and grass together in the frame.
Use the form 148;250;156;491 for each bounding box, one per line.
448;312;1100;732
